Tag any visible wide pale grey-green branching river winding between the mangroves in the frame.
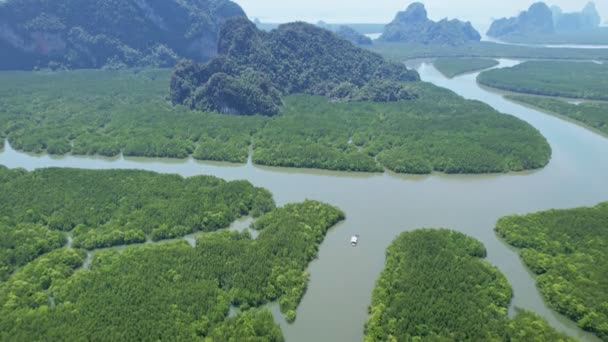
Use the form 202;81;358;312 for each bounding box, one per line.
0;60;608;341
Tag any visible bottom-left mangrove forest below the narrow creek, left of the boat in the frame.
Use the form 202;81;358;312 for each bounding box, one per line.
0;199;344;341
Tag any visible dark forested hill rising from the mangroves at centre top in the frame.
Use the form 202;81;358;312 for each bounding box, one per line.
171;18;420;115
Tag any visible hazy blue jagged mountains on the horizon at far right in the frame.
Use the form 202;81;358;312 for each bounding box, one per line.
487;2;601;41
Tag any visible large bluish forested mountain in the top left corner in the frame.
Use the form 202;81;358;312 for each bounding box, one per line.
0;0;245;70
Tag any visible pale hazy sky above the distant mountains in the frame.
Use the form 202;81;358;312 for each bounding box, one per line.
233;0;608;30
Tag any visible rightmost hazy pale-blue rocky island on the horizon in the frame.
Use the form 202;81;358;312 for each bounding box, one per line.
487;2;608;44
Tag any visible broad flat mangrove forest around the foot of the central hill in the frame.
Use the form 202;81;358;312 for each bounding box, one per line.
0;69;551;173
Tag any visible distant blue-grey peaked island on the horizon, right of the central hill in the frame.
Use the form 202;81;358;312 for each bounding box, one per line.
379;2;481;45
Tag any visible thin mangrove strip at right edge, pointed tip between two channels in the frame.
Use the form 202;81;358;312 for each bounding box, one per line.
507;95;608;134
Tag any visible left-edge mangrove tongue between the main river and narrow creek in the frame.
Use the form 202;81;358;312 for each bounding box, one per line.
0;168;274;250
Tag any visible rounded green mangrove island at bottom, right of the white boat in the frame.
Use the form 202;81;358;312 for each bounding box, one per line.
364;229;573;341
